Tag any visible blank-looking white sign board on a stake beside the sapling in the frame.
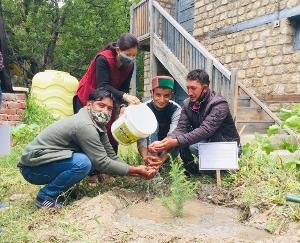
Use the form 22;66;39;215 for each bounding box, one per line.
198;142;239;170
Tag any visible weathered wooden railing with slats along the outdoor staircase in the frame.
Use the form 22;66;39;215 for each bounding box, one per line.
131;0;292;134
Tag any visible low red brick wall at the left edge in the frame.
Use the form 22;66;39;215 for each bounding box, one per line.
0;93;26;126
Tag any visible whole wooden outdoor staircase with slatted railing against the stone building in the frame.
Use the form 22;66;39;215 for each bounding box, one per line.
131;0;289;134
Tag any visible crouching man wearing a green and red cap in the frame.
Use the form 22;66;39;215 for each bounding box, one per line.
137;76;181;166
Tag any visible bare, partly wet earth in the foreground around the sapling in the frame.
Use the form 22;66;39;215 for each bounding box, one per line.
30;191;300;243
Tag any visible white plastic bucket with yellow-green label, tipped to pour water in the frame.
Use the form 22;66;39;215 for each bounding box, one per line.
111;103;157;145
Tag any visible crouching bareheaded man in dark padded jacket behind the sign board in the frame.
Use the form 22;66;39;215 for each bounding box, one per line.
149;69;241;174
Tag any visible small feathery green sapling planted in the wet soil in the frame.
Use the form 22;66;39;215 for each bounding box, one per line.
160;158;199;217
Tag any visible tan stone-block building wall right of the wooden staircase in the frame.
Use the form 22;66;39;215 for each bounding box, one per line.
193;0;300;110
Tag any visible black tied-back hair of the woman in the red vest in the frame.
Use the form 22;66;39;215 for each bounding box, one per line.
105;33;139;51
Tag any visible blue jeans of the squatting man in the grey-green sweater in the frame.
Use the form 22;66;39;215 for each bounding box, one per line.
21;153;92;200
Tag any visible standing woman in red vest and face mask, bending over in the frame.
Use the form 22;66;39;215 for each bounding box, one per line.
73;33;140;152
